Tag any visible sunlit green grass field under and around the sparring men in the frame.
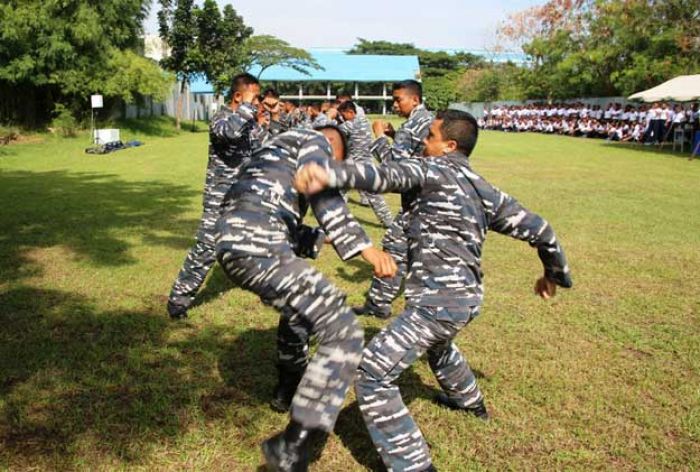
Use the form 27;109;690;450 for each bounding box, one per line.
0;120;700;471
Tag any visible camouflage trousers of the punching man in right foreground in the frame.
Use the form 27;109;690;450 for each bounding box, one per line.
355;307;482;471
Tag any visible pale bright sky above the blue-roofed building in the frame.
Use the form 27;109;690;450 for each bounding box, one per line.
145;0;544;49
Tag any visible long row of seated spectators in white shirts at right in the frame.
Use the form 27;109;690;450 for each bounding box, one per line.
479;102;700;144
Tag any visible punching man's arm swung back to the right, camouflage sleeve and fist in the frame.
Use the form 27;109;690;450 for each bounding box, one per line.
490;188;573;290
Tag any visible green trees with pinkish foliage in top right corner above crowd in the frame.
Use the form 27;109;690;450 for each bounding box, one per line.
501;0;700;99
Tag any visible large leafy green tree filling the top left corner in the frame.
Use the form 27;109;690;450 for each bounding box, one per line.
0;0;167;127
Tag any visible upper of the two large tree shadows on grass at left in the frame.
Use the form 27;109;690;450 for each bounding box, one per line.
0;171;196;282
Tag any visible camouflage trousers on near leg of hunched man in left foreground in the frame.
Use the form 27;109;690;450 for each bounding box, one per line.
217;223;363;432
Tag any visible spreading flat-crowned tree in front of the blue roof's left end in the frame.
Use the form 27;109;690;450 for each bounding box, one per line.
245;35;321;77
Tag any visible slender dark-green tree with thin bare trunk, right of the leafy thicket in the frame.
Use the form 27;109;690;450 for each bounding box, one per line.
158;0;201;129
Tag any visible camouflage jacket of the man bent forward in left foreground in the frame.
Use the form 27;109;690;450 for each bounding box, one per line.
225;129;372;260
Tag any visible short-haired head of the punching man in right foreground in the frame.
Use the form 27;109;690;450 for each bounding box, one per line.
424;110;479;157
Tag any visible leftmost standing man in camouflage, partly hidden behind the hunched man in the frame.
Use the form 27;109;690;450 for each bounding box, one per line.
167;74;260;319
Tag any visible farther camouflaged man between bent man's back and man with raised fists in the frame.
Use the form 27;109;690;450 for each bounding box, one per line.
338;102;394;228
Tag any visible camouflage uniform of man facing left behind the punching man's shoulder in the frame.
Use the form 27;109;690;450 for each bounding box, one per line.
365;104;434;316
